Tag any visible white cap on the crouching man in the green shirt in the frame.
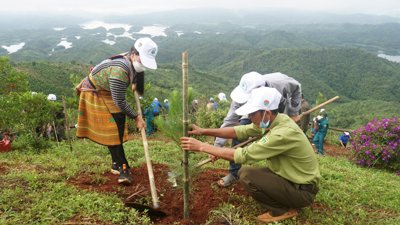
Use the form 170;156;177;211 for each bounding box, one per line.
235;87;282;116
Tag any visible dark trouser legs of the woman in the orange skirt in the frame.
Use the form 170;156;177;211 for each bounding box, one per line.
108;113;129;168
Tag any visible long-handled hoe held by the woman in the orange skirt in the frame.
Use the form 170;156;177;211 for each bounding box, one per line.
125;91;166;216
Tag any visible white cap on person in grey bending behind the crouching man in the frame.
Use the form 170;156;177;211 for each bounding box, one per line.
231;72;265;104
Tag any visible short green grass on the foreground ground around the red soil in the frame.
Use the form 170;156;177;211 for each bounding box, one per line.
0;140;400;224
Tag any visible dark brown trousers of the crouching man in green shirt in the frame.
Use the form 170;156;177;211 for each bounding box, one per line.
239;167;318;216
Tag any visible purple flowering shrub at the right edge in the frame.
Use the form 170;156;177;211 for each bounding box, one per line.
351;117;400;170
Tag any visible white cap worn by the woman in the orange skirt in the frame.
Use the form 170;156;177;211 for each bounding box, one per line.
134;37;158;69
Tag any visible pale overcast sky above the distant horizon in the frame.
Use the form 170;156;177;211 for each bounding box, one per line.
0;0;400;17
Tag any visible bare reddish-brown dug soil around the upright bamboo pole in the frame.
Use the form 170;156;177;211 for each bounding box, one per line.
69;164;248;224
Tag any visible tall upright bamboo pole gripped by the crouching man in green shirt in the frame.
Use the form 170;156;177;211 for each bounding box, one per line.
182;51;189;219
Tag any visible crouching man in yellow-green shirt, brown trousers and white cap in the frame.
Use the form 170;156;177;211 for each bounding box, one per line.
181;87;320;223
